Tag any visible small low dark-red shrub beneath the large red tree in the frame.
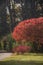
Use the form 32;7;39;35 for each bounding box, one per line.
12;46;31;53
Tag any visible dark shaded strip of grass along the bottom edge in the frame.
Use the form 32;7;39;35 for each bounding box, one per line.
0;60;43;65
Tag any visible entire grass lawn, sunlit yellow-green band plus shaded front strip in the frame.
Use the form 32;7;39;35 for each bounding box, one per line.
0;54;43;65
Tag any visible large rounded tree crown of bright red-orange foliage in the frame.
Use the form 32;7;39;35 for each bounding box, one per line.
12;17;43;43
